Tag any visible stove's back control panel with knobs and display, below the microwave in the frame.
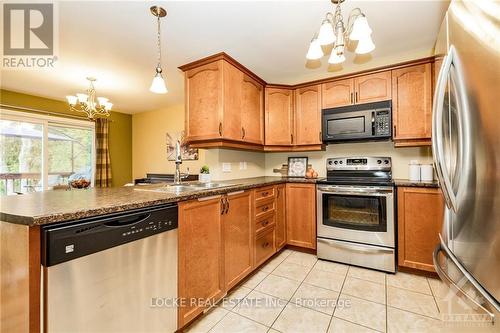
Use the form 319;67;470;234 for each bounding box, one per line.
326;157;392;170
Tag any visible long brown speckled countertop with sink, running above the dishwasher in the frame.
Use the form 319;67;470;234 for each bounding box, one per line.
0;177;317;226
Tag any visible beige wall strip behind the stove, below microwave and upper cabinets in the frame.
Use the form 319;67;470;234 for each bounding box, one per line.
265;142;432;179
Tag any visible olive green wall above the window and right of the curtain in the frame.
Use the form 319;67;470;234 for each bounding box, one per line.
0;89;132;186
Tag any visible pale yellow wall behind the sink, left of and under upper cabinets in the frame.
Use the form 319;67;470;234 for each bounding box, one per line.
132;105;265;180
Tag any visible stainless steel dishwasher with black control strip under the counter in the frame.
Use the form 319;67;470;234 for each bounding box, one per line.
42;205;178;333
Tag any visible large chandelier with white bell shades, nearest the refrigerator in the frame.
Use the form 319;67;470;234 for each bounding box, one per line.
306;0;375;64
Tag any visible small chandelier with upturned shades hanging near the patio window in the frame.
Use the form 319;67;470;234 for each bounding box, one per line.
66;77;113;119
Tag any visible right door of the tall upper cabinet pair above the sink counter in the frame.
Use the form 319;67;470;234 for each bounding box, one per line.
241;74;264;144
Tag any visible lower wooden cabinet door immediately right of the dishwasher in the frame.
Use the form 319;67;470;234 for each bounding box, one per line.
178;197;225;328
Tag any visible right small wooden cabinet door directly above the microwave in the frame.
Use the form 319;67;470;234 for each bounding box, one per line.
354;71;391;104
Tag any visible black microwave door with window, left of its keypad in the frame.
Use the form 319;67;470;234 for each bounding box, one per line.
323;111;374;141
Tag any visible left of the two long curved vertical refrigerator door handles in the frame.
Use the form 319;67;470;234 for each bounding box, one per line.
432;46;457;212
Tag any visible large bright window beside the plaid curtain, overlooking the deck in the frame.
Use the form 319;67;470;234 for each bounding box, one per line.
0;110;95;195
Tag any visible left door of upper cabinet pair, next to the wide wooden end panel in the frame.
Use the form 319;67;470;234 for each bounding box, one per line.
222;62;243;141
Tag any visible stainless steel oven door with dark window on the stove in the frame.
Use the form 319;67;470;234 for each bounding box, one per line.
317;185;394;247
